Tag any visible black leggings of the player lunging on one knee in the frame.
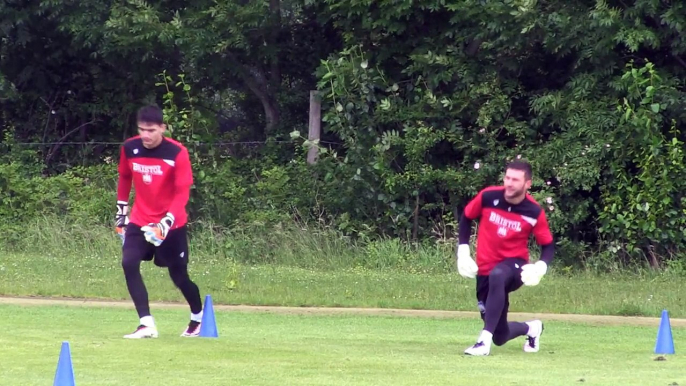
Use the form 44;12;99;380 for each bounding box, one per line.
476;258;529;346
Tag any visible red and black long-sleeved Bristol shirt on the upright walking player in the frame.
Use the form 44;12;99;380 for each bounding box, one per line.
117;136;193;229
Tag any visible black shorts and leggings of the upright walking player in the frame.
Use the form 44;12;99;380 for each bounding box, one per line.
122;224;202;318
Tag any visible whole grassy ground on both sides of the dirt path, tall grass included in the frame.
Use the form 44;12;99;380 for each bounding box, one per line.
0;220;686;386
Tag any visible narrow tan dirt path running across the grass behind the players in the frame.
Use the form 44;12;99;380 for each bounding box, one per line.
0;297;686;327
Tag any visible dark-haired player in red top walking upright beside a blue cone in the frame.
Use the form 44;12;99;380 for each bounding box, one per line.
116;106;202;339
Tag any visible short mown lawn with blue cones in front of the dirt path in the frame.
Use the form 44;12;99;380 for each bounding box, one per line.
0;304;686;386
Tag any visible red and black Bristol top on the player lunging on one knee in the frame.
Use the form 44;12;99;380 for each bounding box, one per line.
464;186;553;275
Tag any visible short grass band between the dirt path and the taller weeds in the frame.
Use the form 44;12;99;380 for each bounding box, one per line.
0;252;686;317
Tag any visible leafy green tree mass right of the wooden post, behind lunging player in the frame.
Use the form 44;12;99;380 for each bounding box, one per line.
320;0;686;266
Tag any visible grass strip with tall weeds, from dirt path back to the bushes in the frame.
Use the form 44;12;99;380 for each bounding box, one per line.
0;218;686;317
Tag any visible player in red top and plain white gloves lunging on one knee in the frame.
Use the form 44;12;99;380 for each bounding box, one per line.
457;161;554;355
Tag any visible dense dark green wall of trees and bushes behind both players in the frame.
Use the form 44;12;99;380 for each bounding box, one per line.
0;0;686;266
